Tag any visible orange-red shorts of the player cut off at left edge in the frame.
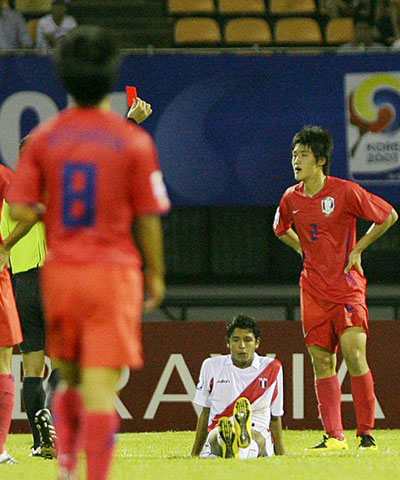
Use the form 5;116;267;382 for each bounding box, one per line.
0;268;23;347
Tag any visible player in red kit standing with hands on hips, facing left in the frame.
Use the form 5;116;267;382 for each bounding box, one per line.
274;126;397;451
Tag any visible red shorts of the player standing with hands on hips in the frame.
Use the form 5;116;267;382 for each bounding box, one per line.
300;289;368;353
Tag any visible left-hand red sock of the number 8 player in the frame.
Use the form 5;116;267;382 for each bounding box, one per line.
52;388;83;471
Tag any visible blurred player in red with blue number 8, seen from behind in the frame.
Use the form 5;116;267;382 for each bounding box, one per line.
7;27;170;480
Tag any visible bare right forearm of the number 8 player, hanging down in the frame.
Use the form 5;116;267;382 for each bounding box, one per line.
134;215;165;275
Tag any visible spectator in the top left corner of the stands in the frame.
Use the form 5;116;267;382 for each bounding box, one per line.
0;2;32;50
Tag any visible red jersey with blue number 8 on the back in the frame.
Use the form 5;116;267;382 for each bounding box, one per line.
7;108;170;266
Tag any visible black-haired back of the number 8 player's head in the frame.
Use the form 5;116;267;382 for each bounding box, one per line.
54;26;119;107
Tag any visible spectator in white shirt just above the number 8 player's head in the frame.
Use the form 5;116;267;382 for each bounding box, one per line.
36;0;77;49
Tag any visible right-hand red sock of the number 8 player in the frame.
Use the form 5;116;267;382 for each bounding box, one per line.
85;411;119;480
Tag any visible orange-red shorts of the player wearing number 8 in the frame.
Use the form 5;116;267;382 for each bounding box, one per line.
41;262;143;368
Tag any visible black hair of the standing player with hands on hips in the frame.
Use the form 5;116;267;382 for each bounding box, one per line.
292;125;333;175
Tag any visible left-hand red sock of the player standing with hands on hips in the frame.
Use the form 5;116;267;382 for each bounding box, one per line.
315;375;344;440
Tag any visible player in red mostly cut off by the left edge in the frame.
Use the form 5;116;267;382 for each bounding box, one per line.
0;164;22;464
